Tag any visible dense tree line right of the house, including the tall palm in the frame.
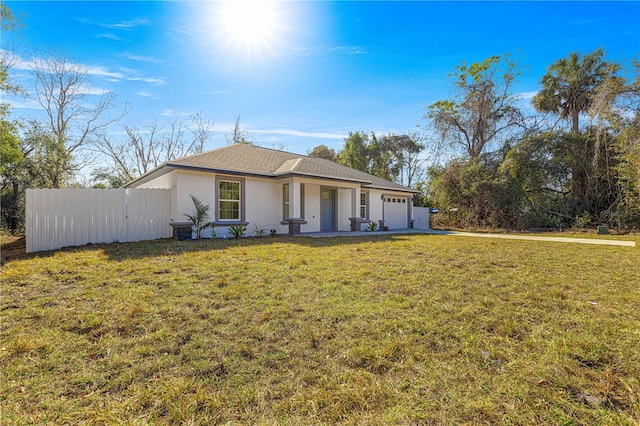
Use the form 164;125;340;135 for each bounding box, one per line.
310;49;640;229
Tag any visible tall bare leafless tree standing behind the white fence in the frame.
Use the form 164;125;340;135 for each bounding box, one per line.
30;51;126;188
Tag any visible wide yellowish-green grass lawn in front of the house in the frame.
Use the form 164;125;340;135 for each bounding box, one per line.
0;235;640;425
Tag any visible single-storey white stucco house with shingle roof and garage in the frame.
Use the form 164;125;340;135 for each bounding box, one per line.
126;144;416;236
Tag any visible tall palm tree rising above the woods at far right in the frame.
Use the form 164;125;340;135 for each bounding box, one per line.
533;49;618;133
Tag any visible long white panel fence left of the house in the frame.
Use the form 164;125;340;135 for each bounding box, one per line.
26;189;171;253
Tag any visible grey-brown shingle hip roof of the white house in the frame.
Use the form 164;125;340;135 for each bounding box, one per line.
138;144;416;192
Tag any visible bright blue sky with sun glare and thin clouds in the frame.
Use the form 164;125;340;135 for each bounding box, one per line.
2;1;640;153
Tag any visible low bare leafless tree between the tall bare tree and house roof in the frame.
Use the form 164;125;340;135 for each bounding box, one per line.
94;114;213;185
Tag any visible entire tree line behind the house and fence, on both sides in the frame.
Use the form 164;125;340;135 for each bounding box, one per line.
0;3;640;232
